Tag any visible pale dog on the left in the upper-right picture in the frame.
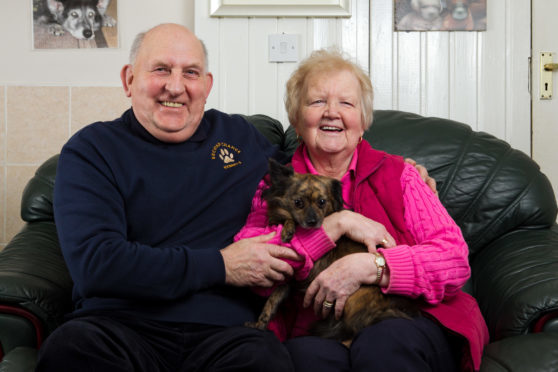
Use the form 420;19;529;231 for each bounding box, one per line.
398;0;444;31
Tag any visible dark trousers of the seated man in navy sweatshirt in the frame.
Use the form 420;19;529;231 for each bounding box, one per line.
36;315;293;372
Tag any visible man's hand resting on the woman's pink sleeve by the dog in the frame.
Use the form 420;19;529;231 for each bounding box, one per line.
221;233;300;287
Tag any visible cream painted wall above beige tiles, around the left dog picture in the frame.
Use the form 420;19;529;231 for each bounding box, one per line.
0;0;194;86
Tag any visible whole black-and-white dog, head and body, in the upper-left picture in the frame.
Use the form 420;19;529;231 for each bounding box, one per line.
33;0;116;40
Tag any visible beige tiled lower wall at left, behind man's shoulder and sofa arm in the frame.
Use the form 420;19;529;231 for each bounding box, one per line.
0;86;130;247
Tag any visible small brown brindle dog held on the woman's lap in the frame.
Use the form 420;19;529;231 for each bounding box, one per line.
248;160;419;343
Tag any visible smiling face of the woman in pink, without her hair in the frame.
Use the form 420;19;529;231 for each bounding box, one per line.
296;70;364;158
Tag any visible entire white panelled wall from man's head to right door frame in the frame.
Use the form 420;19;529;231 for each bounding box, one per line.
199;0;530;154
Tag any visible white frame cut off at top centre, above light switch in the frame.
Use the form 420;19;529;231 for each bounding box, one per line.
209;0;351;17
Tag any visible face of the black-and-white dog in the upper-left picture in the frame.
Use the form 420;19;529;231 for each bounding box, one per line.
46;0;110;40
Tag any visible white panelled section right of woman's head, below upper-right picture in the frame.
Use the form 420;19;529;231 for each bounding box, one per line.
371;0;531;154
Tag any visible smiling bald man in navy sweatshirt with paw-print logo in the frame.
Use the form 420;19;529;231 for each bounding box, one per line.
37;24;297;371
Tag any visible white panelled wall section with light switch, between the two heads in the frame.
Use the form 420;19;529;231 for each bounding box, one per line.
195;0;370;125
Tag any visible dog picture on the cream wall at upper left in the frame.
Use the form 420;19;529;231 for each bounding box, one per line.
31;0;118;49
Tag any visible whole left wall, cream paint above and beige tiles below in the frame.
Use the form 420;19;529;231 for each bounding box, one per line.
0;0;197;249
